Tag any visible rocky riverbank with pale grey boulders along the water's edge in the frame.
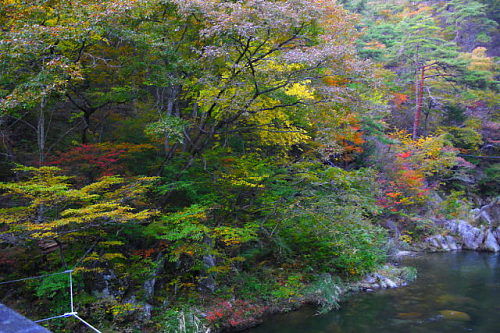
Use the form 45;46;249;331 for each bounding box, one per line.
185;199;500;332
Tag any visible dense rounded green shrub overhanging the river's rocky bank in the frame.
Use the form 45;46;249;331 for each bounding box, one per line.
268;164;386;275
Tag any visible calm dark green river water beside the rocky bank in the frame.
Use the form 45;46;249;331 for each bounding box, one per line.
247;252;500;333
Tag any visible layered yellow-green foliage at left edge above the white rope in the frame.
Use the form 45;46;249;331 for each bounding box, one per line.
0;166;156;238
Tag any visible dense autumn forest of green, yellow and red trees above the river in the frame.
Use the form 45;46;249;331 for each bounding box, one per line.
0;0;500;333
